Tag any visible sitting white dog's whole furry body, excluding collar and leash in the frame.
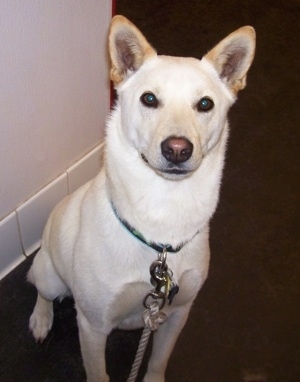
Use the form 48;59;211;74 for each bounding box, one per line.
28;16;255;382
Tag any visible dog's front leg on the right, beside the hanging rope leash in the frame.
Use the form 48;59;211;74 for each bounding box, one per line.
143;305;190;382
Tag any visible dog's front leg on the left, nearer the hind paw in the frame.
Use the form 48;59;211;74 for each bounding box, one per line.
77;308;109;382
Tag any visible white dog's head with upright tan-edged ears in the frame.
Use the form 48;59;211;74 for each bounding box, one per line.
109;16;255;179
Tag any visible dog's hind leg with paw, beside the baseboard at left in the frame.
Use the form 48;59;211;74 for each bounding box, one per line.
27;250;68;342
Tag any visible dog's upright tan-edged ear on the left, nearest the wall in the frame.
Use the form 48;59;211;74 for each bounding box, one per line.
108;15;156;84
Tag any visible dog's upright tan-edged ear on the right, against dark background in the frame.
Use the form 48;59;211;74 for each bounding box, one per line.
205;26;255;94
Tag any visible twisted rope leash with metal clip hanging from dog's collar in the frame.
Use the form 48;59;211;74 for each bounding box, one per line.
127;247;179;382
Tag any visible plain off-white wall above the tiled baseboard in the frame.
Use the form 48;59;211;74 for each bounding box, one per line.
0;0;112;280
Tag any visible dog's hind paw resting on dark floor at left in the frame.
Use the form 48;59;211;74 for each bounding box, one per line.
29;309;53;343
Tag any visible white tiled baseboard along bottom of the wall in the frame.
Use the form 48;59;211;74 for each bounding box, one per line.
0;144;103;280
